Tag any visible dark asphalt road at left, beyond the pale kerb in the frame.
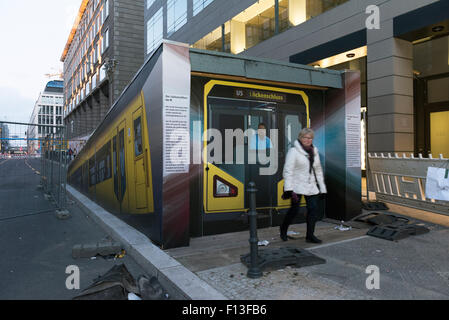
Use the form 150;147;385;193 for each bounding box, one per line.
0;159;148;300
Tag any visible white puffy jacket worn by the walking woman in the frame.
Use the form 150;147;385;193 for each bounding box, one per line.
283;140;327;196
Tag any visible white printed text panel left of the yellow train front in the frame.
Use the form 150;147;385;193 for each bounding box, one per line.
163;93;190;176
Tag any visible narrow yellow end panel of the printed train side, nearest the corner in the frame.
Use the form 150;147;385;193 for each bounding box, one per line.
133;107;148;209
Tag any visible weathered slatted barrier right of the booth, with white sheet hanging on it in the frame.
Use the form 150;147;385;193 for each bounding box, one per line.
367;153;449;215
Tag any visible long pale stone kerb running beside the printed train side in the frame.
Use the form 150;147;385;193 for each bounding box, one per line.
67;185;228;300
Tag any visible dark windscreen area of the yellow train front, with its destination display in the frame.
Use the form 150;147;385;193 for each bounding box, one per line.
206;82;308;209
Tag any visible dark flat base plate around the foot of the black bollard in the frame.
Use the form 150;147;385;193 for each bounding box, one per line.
240;247;326;271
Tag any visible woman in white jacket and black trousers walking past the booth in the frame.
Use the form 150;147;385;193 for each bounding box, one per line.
280;128;327;243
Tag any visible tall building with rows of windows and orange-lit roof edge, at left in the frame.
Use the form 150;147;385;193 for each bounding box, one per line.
61;0;144;141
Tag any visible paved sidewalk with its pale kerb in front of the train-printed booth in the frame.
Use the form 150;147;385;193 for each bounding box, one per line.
68;186;449;300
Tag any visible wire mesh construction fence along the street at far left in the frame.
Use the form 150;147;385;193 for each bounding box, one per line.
0;121;68;217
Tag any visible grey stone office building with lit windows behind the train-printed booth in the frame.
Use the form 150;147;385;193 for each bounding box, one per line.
145;0;449;158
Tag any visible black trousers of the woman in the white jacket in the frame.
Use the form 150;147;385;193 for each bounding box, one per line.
281;194;320;238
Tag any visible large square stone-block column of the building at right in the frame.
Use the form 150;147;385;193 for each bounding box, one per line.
367;26;414;155
